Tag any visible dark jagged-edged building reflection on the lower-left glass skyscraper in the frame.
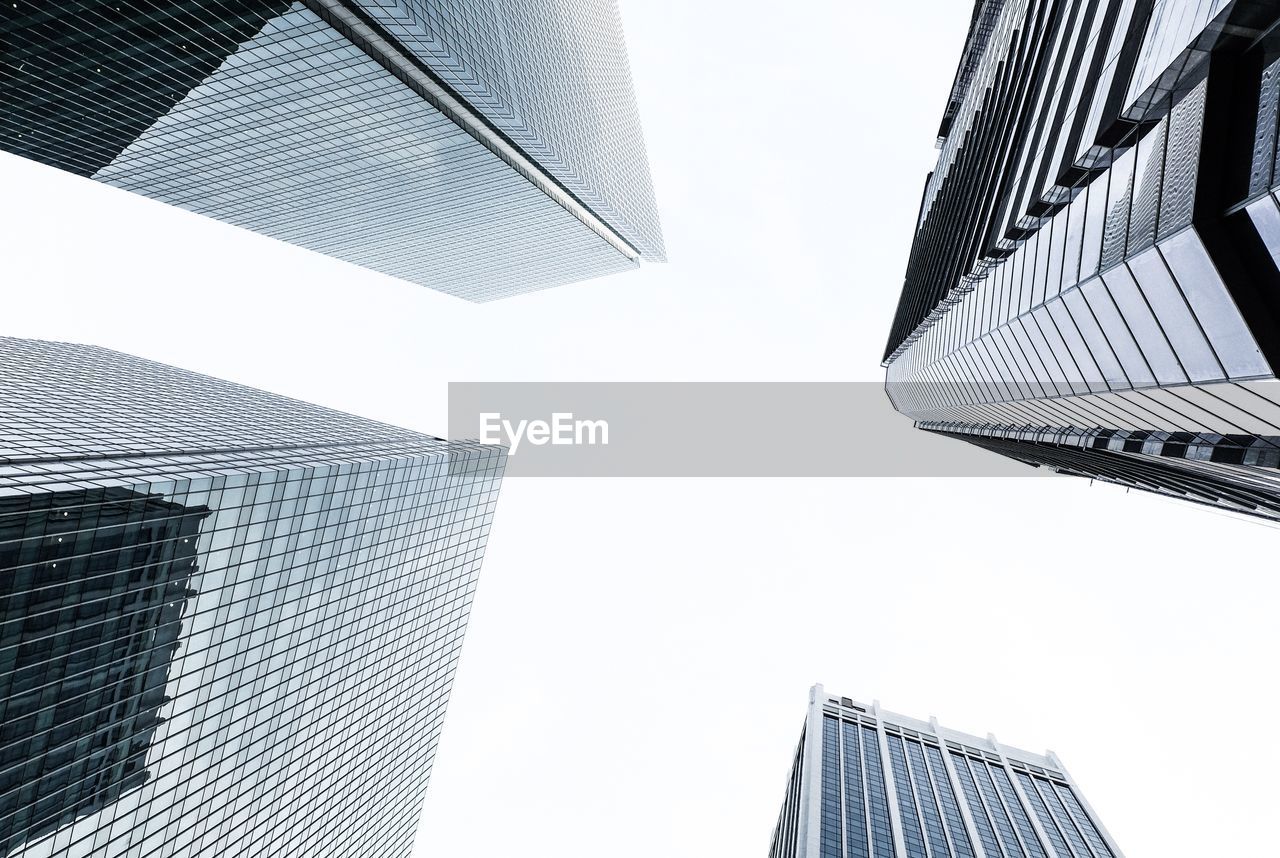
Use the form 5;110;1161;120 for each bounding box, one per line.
0;488;209;855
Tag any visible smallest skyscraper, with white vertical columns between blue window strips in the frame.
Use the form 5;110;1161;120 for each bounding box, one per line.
769;685;1123;858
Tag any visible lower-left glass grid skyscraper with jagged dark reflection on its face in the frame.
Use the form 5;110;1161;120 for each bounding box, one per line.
0;338;504;858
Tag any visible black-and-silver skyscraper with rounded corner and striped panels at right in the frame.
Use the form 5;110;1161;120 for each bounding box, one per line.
884;0;1280;519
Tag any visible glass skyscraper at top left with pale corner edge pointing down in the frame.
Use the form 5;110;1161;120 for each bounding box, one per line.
0;0;664;301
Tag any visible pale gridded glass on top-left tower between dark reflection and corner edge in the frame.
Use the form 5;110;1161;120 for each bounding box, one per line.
95;4;635;300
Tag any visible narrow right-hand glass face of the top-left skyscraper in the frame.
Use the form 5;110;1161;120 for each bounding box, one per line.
358;0;666;261
